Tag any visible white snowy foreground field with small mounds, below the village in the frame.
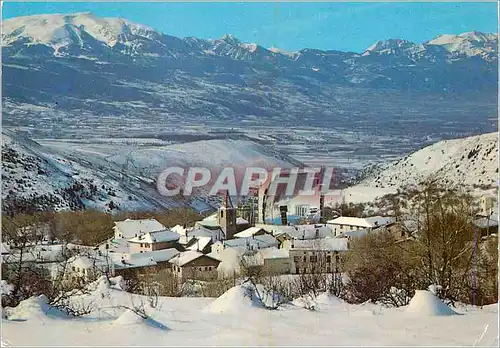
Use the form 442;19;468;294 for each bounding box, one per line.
2;282;498;346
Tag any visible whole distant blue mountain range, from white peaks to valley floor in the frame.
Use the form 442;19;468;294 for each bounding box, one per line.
2;13;498;115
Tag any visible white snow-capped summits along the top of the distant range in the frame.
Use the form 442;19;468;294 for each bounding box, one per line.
2;12;498;60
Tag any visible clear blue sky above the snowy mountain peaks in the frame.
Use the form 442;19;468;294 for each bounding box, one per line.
2;2;498;52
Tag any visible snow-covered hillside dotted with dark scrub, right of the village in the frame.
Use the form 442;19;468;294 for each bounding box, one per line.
360;133;498;190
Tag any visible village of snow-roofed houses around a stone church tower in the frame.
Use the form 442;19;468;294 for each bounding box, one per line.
2;181;498;298
